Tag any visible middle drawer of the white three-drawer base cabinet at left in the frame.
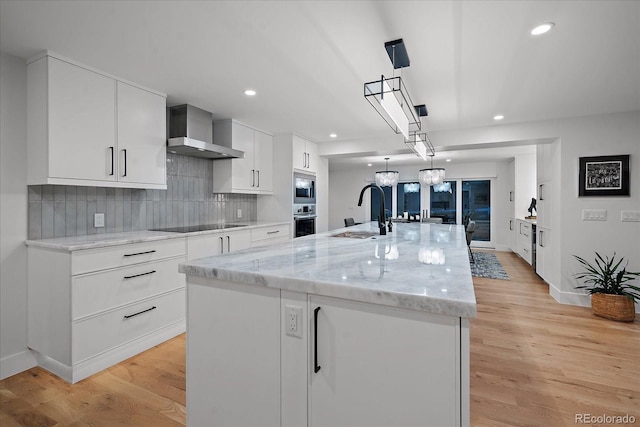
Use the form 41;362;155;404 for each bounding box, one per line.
71;256;185;319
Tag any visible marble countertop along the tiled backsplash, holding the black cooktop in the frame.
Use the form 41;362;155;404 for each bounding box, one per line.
25;221;289;252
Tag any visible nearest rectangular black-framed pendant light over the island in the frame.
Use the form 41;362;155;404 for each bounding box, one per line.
364;75;420;139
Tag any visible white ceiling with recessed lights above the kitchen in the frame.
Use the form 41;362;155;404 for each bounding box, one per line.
0;0;640;164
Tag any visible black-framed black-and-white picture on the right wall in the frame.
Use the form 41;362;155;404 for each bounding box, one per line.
578;154;630;197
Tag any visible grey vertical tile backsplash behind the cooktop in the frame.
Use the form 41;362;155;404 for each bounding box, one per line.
28;153;258;239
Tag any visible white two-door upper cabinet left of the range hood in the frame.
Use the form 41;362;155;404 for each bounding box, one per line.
27;53;166;189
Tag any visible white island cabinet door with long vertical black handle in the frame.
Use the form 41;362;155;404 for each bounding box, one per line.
309;296;460;426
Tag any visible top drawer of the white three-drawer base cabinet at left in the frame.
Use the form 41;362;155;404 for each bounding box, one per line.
71;237;186;275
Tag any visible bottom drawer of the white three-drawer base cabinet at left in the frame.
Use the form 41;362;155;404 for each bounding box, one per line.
72;289;185;364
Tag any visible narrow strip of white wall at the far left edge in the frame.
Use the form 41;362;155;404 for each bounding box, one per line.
0;54;36;379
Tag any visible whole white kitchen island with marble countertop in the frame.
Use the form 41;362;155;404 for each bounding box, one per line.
180;223;476;426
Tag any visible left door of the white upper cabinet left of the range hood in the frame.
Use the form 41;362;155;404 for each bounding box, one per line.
48;58;117;181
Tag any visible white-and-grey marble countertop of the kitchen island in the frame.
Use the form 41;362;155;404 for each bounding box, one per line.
179;223;476;317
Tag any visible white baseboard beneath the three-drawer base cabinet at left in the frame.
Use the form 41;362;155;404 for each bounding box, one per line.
37;320;186;384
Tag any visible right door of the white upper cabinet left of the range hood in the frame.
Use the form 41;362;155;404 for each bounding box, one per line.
118;82;167;185
